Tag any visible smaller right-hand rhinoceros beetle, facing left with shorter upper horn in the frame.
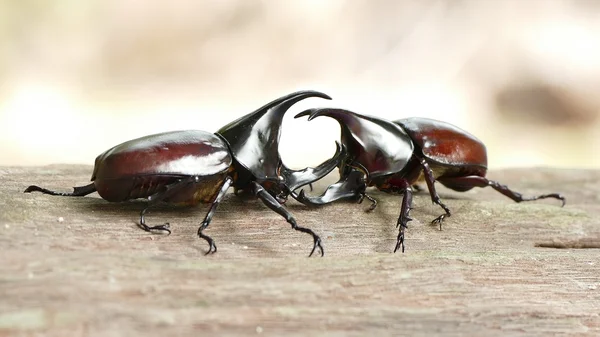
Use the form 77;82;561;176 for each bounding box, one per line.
296;108;565;252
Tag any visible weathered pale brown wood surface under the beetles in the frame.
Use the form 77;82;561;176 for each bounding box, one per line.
0;165;600;336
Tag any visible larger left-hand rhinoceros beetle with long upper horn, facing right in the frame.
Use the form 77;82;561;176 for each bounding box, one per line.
25;91;343;256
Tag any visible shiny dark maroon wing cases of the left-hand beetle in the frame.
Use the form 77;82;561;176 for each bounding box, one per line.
92;130;232;181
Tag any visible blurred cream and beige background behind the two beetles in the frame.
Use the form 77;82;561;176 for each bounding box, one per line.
0;0;600;169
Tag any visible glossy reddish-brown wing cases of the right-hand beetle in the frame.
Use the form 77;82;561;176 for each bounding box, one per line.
394;117;487;170
